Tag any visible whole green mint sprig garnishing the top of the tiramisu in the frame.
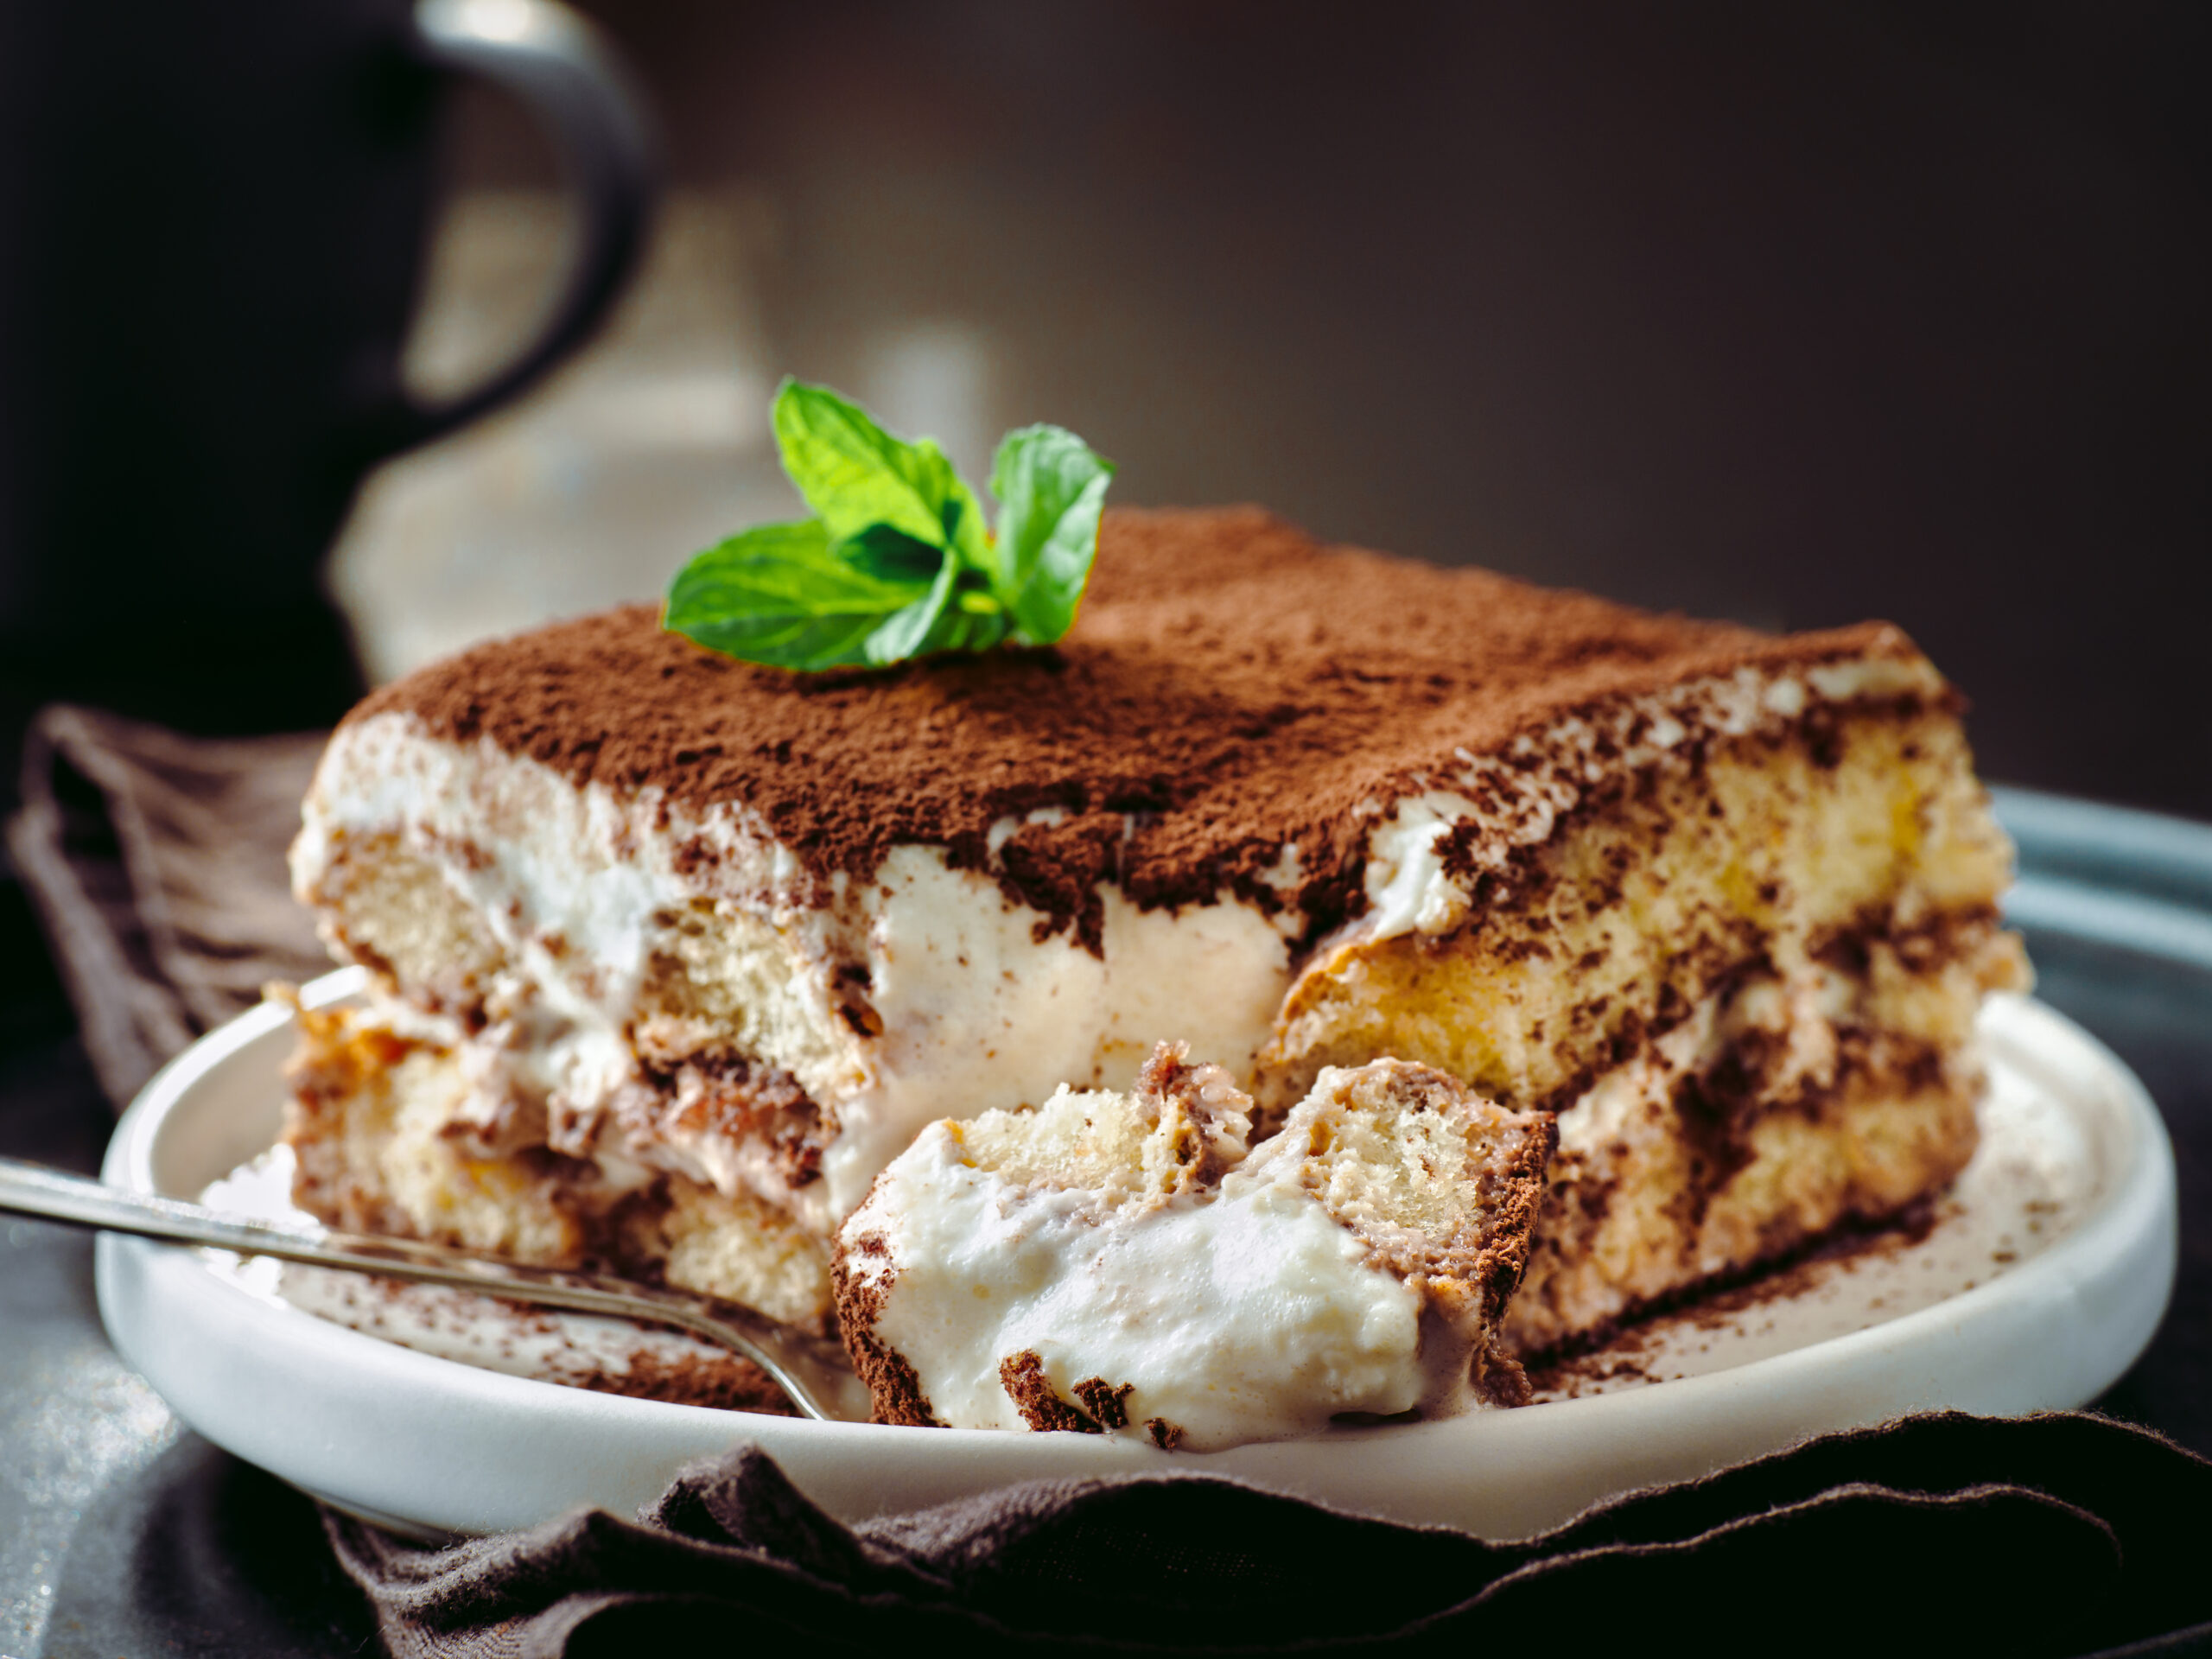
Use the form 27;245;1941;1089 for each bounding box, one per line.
661;380;1113;671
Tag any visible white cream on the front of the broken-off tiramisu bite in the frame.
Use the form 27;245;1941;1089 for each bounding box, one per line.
845;1123;1429;1451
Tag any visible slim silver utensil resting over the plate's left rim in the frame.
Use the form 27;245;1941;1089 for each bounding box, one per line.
0;1157;869;1422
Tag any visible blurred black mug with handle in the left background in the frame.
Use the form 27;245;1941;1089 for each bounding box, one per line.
0;0;655;791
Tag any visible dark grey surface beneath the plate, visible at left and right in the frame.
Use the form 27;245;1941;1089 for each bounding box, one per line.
0;797;2212;1659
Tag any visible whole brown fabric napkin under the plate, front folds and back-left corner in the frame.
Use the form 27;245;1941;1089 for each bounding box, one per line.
9;708;2212;1659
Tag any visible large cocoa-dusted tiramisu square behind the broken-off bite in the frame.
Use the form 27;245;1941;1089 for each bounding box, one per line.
289;511;2024;1407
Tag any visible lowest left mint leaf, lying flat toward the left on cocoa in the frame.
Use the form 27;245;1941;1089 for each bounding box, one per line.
661;518;929;668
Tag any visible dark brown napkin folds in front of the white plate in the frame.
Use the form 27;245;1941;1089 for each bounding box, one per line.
325;1414;2212;1659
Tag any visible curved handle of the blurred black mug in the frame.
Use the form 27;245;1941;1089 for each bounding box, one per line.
372;0;659;455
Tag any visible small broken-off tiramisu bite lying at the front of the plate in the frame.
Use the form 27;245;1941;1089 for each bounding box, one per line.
836;1044;1553;1451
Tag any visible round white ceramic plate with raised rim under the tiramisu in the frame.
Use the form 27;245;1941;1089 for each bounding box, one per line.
98;973;2177;1537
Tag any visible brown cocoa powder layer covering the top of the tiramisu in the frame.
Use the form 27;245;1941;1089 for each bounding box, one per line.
352;506;1911;947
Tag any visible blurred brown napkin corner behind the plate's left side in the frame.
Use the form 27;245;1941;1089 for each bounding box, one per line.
7;706;329;1110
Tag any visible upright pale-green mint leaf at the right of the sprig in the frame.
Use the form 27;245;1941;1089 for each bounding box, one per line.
991;427;1115;646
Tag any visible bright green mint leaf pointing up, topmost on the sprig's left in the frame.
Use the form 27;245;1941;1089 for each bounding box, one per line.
774;380;987;569
